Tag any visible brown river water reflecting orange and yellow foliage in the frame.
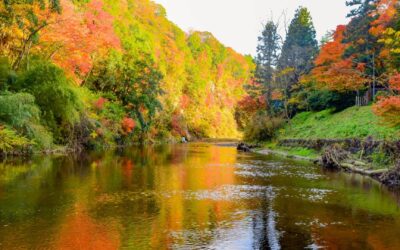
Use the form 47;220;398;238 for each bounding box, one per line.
0;144;400;249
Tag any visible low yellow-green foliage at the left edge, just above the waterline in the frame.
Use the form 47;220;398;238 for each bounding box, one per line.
0;127;32;154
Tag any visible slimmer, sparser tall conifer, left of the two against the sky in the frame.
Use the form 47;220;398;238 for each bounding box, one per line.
253;21;281;113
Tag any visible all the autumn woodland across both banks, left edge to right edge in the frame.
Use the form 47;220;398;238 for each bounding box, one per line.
0;0;400;154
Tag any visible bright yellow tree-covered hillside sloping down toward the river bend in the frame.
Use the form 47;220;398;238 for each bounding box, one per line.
104;0;254;138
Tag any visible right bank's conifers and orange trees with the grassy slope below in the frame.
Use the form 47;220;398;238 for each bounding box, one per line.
240;0;400;144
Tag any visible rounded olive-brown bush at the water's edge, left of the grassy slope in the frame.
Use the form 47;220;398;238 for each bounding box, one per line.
244;112;285;141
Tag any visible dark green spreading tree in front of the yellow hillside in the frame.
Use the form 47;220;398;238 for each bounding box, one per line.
87;53;163;140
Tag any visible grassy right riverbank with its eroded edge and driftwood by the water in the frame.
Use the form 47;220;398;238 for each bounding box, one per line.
238;106;400;188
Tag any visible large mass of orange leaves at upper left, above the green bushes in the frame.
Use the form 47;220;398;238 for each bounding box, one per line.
41;0;120;81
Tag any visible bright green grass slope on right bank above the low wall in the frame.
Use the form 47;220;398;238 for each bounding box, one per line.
279;106;400;140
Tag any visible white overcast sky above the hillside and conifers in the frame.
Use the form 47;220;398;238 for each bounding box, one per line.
155;0;348;55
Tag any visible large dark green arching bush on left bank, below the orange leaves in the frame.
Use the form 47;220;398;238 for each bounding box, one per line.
13;62;83;143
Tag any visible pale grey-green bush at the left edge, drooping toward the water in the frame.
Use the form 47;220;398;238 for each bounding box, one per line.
0;92;53;149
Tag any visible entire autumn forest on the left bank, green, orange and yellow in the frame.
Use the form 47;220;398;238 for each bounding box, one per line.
0;0;254;153
